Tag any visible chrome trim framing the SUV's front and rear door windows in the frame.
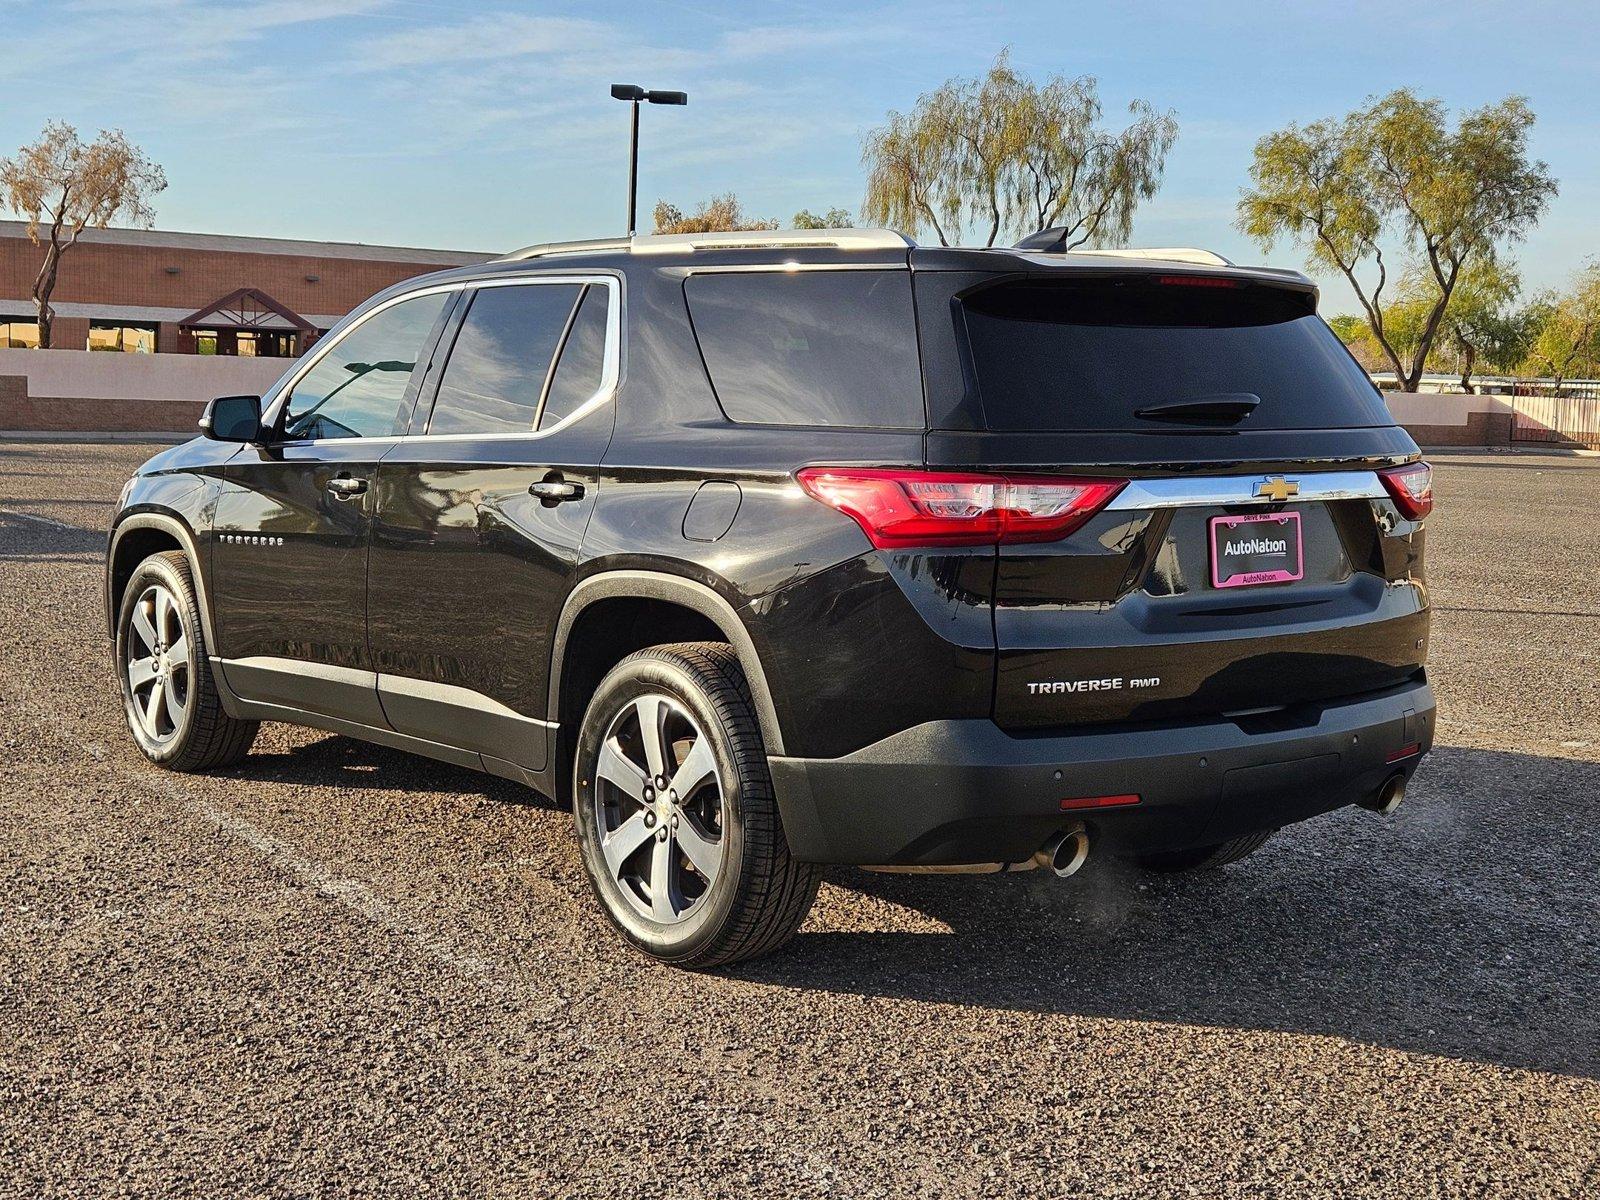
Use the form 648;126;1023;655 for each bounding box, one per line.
262;270;622;446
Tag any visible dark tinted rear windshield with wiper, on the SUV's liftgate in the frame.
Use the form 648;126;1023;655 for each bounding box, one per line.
962;275;1394;430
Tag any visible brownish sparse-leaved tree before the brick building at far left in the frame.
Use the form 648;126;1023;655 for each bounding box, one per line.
0;122;166;350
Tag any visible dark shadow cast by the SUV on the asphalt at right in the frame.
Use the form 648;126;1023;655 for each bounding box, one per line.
736;749;1600;1077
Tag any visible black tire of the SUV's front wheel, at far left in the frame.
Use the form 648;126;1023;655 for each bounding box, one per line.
114;550;261;771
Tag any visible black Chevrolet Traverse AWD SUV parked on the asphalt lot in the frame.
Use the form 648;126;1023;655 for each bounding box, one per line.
106;230;1434;966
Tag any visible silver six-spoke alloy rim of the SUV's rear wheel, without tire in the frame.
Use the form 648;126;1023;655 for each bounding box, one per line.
592;693;725;925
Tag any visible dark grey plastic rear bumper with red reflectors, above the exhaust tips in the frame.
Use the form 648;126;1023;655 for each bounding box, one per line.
768;683;1434;866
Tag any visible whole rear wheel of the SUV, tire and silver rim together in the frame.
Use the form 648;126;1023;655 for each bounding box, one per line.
573;642;819;968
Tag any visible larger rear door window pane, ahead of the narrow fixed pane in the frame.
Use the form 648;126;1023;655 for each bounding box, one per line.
427;283;582;434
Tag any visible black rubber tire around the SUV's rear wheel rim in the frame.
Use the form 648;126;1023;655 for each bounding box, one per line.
573;642;821;968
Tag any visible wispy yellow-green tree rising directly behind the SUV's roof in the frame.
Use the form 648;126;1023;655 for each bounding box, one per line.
861;51;1178;250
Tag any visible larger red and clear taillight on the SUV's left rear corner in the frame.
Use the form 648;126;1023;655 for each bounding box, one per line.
795;467;1126;550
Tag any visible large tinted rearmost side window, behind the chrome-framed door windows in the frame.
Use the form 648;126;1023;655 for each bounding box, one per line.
685;270;923;429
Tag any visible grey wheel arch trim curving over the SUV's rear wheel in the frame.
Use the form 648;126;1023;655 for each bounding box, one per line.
549;570;784;800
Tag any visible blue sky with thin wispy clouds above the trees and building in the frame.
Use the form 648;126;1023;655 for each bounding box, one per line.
0;0;1600;310
